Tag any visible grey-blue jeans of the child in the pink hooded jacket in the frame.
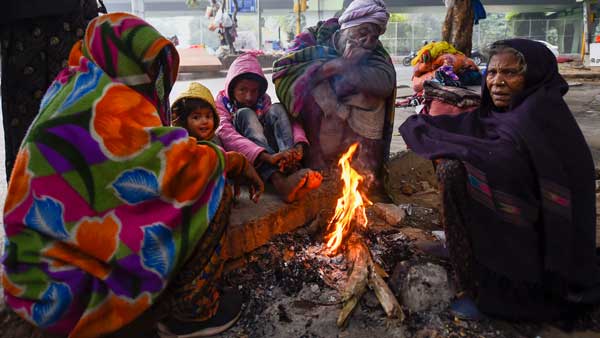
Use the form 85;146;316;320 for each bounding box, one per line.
233;104;294;181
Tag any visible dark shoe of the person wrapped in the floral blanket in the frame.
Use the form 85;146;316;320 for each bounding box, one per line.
158;289;242;338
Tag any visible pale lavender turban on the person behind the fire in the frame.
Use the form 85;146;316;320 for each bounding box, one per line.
339;0;390;34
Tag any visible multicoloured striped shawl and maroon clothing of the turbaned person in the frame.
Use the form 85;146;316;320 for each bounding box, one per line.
273;18;396;172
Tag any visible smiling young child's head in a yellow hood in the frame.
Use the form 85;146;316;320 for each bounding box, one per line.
171;82;221;145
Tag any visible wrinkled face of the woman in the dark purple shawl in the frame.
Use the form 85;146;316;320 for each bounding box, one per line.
486;53;525;109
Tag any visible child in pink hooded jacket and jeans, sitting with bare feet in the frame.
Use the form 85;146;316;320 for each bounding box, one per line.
216;53;323;202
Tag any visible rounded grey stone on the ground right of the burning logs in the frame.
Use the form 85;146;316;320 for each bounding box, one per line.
401;263;454;312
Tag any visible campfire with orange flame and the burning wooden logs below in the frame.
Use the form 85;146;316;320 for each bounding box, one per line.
325;143;404;327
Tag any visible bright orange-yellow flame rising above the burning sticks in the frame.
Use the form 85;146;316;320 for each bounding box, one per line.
325;143;373;254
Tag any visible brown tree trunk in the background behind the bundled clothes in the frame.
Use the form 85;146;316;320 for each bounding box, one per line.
442;0;474;56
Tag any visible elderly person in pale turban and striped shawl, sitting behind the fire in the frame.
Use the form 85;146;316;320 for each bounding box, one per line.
273;0;396;178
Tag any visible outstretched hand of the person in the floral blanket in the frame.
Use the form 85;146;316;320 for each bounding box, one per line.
225;151;265;203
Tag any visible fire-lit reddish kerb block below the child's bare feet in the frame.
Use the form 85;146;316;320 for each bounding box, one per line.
223;180;341;259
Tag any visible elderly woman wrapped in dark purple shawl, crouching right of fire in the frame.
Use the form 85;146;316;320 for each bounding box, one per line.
400;39;600;320
